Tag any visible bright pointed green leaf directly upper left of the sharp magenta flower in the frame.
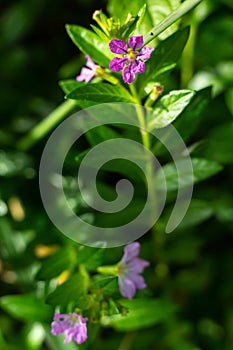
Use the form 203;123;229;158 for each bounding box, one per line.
66;25;113;67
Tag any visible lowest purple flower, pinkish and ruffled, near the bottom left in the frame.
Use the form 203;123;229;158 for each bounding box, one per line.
51;312;87;344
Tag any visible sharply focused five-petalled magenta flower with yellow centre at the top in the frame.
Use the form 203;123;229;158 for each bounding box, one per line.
109;36;154;84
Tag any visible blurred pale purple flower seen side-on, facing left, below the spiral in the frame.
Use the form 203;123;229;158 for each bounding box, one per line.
118;242;149;299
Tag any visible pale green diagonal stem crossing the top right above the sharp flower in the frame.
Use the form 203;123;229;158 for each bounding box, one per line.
143;0;202;46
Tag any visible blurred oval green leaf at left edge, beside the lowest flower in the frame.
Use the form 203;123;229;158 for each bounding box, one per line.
0;294;53;322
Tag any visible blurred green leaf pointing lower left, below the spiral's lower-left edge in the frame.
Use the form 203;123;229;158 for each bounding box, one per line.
36;248;76;280
